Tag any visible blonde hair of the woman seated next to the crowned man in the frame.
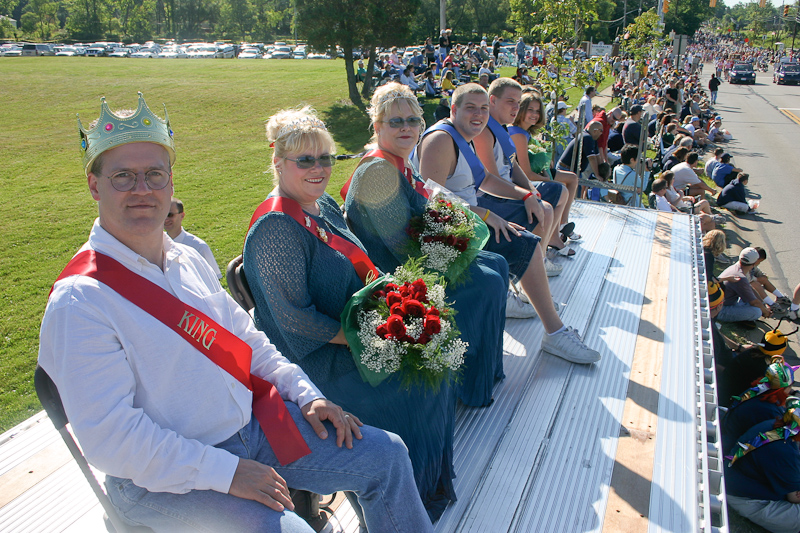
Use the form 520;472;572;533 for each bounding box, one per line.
267;106;336;184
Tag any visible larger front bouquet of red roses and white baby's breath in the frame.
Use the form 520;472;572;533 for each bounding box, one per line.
342;260;467;388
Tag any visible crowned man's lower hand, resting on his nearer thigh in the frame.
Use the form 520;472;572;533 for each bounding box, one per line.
228;458;294;512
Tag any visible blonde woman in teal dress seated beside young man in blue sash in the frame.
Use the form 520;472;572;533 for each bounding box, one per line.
344;83;508;406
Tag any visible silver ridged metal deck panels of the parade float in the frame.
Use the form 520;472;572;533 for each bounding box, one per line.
0;202;727;533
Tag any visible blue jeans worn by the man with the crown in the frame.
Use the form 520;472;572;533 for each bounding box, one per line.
106;402;433;533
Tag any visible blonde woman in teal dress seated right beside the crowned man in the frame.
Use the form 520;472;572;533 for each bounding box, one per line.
244;108;455;521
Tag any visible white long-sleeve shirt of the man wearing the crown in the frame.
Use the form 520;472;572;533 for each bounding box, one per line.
39;221;322;493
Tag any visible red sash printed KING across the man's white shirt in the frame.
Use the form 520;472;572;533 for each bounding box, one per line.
51;250;311;465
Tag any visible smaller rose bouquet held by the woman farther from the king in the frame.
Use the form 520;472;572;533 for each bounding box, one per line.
407;191;489;282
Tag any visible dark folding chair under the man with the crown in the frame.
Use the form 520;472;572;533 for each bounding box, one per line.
33;366;153;533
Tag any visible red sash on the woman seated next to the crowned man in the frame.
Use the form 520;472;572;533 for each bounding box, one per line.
247;196;381;285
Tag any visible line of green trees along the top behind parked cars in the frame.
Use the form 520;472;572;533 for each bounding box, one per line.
0;0;725;46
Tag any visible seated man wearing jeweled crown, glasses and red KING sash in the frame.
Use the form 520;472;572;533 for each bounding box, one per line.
39;93;431;532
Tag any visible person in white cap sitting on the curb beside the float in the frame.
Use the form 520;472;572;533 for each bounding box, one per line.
717;247;772;322
